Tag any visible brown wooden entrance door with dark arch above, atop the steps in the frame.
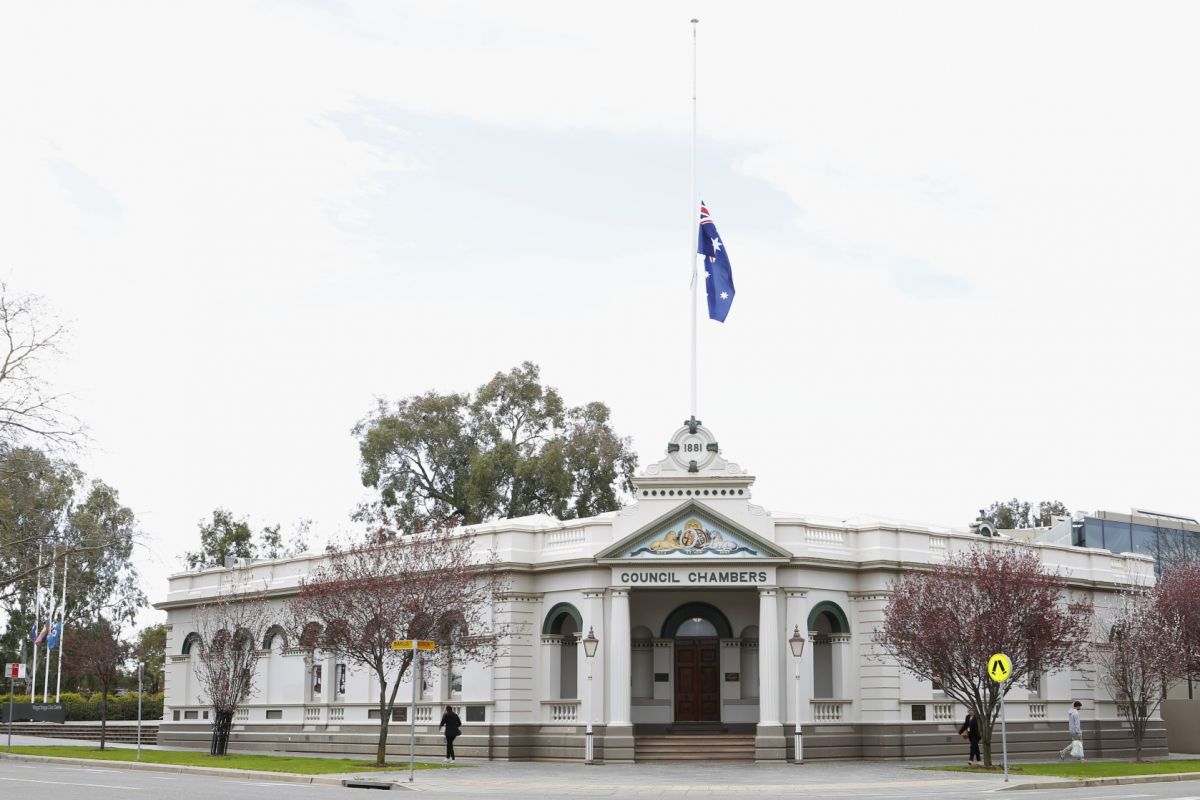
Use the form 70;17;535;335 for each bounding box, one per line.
662;603;733;722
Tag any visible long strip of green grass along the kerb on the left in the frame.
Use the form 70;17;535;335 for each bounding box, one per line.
0;746;445;775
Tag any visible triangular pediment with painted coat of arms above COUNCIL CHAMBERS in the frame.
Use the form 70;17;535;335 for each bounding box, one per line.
596;500;791;560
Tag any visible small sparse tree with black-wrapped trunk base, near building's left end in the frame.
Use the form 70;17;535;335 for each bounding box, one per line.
193;578;272;756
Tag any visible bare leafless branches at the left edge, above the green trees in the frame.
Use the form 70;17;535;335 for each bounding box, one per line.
0;283;82;447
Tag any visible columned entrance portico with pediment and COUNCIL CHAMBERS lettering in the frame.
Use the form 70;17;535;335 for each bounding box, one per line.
596;470;791;760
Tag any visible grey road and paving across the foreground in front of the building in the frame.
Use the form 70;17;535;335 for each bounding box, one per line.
0;759;1200;800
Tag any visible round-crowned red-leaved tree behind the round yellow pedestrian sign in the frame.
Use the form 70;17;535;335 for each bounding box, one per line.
875;542;1092;766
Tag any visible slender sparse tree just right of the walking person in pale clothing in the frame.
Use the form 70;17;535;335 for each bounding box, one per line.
1092;588;1190;762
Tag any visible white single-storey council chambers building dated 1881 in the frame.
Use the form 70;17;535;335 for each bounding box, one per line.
157;422;1165;763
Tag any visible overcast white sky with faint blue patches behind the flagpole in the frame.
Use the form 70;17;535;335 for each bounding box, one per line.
0;0;1200;621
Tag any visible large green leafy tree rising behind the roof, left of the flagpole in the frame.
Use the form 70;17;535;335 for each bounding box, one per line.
354;361;637;531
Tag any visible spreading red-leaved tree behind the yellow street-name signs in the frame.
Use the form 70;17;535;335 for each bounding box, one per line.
292;529;505;766
